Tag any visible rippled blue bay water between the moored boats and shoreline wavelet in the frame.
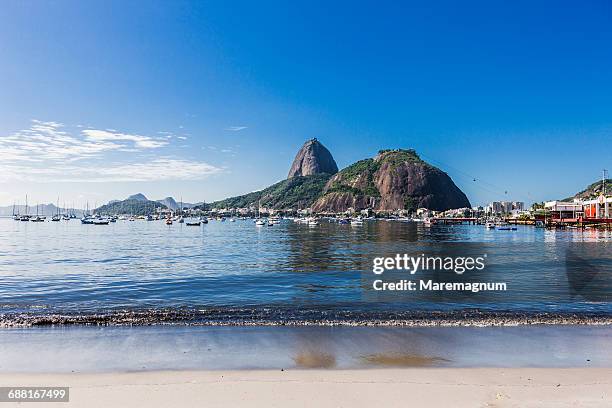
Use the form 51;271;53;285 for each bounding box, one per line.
0;219;612;321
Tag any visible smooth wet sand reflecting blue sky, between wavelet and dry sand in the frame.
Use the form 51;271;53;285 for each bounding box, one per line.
0;325;612;373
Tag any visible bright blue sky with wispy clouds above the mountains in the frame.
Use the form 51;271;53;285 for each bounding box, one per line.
0;0;612;207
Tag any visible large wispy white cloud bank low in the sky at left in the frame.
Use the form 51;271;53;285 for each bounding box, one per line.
0;120;223;182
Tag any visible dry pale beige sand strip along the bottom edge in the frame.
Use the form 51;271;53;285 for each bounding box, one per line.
0;368;612;408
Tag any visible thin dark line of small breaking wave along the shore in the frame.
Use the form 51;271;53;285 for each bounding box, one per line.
0;309;612;327
